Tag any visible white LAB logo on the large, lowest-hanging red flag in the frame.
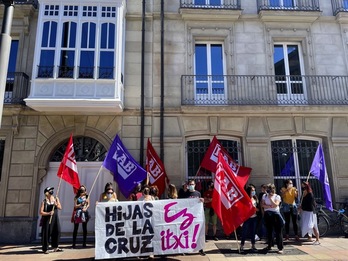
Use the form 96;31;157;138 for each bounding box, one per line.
214;162;243;209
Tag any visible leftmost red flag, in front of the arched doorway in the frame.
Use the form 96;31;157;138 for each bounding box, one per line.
57;134;80;193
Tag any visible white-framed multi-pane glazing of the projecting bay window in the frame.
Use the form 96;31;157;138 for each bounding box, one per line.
37;5;117;79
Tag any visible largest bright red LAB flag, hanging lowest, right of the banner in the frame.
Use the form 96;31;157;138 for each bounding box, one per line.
212;153;256;235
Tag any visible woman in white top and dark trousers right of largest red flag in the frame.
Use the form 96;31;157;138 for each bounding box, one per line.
261;184;284;254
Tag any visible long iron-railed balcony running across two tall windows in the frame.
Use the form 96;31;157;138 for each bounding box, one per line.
181;75;348;106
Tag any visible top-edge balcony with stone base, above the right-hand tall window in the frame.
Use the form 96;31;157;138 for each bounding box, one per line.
257;0;321;23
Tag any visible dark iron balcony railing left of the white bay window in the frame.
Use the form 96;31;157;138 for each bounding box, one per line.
4;72;29;104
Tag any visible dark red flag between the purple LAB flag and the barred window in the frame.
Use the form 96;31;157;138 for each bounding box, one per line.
146;139;169;197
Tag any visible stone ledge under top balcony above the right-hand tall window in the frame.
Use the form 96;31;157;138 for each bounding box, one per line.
259;10;321;23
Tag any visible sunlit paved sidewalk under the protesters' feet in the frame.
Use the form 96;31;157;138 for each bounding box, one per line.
0;237;348;261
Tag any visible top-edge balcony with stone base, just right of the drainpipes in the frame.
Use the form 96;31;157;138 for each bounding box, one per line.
180;0;242;21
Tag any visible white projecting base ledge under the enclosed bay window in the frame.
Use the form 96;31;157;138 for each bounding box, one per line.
24;98;124;114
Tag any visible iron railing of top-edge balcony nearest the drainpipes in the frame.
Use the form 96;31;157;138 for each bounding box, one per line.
180;0;241;10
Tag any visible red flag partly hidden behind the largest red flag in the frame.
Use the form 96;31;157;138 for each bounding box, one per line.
201;136;252;187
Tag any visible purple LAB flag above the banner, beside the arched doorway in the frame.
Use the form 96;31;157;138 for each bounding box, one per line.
103;135;147;198
